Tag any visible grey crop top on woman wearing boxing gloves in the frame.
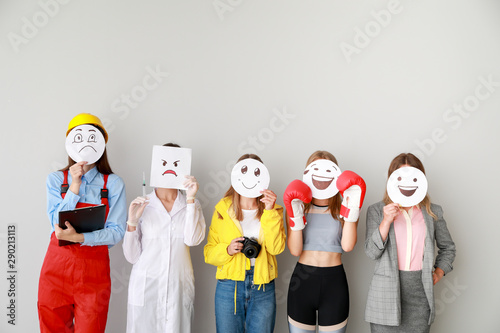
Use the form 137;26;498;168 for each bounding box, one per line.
302;205;343;253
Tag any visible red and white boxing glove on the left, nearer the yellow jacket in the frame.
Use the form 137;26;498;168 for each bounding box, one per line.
283;179;312;230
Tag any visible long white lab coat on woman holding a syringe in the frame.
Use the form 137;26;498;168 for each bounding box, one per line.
123;191;206;333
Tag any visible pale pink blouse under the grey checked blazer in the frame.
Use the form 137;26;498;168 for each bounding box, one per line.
394;206;427;271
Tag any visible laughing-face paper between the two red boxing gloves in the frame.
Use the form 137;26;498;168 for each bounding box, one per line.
302;159;342;199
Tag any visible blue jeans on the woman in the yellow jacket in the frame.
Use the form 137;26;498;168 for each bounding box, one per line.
215;267;276;333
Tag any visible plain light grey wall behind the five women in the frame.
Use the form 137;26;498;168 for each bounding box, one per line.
0;0;500;333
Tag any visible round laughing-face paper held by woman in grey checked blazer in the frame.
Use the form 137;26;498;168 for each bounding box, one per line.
387;167;428;207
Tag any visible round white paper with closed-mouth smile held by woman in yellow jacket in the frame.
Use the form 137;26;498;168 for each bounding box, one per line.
231;158;271;198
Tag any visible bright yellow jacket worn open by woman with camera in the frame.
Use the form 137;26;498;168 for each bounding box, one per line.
204;197;286;284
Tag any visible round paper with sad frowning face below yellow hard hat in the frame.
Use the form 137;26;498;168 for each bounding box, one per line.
66;124;106;164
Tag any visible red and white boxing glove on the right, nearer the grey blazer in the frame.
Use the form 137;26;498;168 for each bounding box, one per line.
337;170;366;222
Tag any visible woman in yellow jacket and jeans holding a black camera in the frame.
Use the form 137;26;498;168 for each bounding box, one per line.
204;154;286;333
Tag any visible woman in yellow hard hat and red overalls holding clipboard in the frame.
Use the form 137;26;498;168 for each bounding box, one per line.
38;113;127;333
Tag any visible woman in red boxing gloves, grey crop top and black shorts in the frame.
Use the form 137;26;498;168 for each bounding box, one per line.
283;151;366;333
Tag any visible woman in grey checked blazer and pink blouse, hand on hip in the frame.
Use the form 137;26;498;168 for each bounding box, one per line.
365;154;455;333
